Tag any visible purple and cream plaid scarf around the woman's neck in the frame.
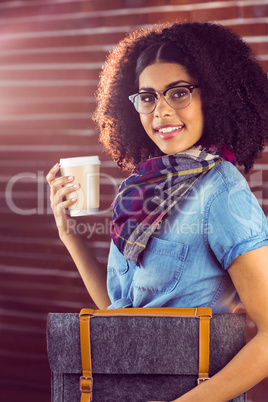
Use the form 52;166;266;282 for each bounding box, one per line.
111;146;231;265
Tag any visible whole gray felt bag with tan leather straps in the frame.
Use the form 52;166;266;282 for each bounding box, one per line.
47;308;246;402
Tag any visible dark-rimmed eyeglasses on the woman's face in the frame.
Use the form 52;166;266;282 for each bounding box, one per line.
129;85;199;114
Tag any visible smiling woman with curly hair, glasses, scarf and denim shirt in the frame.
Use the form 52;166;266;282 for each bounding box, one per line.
47;23;268;402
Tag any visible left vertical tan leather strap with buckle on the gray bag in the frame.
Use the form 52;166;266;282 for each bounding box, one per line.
80;314;93;402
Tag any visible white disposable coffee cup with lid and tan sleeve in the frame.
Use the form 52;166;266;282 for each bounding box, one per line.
60;156;100;216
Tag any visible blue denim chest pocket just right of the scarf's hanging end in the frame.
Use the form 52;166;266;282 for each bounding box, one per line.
133;237;188;293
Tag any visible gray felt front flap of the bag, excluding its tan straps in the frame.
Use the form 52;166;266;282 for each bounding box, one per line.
47;313;246;375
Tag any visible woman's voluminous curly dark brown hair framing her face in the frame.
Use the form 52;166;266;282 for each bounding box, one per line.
93;22;268;172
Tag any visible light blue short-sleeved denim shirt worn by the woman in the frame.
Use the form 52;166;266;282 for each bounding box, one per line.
107;161;268;313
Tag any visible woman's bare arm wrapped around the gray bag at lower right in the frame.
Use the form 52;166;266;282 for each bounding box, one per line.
170;246;268;402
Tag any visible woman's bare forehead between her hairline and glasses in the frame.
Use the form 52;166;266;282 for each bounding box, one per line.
139;62;193;90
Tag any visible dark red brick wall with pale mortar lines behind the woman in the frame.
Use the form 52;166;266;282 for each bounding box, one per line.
0;0;268;402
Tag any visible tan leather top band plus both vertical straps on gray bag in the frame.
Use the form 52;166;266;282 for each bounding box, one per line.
80;307;212;402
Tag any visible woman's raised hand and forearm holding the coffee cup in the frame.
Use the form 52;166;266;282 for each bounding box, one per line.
47;164;110;309
